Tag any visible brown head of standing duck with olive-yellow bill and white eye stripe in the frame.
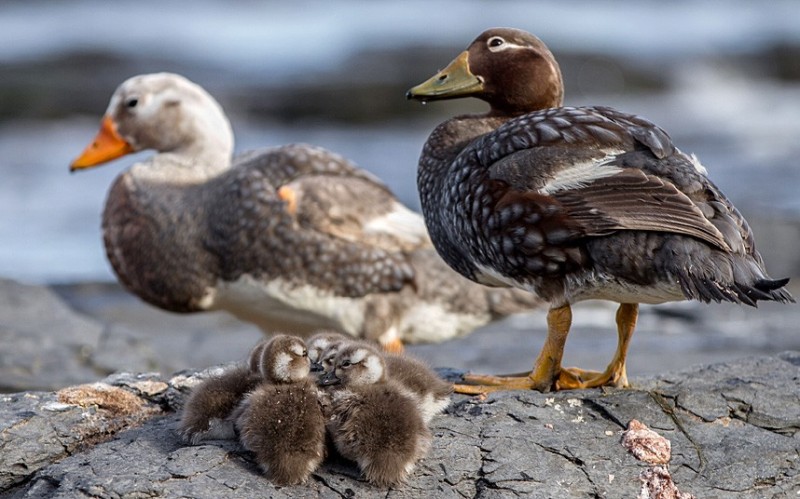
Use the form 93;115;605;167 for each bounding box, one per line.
406;28;564;115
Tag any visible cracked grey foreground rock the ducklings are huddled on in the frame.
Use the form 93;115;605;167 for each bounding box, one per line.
0;352;800;499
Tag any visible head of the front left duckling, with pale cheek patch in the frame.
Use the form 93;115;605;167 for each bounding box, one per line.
261;334;311;383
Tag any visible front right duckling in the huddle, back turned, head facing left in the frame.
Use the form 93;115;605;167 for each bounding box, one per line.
321;342;432;487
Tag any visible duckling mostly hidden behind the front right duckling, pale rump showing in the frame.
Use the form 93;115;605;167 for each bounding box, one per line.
307;332;453;424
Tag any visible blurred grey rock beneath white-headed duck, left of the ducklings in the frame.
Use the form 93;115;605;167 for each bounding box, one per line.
0;278;263;393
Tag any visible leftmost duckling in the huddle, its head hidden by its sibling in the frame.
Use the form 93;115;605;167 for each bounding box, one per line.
179;365;262;445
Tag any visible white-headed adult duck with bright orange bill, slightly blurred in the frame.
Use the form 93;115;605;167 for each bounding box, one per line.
70;73;540;351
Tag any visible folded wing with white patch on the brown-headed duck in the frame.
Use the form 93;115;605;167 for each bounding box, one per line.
462;108;729;250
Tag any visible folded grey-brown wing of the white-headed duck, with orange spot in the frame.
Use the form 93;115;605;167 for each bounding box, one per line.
205;145;414;297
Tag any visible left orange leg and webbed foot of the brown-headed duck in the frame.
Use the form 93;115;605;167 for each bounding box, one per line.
453;305;572;395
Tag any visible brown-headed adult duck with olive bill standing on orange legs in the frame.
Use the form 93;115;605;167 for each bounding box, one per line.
407;28;794;394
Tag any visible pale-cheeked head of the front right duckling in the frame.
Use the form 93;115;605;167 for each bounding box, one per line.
320;343;386;386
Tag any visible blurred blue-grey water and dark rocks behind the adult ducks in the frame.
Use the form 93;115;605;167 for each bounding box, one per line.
0;0;800;283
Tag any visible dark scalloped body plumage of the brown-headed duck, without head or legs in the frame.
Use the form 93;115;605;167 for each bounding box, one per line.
419;107;786;305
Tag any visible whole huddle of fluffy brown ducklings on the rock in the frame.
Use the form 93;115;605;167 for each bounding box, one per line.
180;332;452;487
